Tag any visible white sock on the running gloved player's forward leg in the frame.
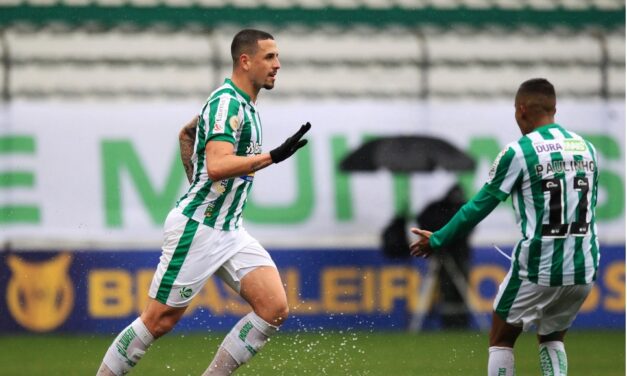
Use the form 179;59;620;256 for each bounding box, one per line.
203;312;279;376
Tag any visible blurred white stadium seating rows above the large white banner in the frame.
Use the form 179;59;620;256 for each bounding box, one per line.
5;20;625;98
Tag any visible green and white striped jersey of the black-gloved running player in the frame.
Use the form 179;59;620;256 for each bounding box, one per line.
177;79;262;230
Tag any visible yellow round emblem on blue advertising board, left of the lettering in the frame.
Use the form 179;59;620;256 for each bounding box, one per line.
6;253;74;332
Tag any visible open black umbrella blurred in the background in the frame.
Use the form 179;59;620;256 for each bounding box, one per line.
340;136;475;172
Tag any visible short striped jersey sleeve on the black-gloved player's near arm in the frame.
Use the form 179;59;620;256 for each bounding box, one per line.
203;94;242;144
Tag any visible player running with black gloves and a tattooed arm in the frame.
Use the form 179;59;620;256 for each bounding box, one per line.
98;29;311;375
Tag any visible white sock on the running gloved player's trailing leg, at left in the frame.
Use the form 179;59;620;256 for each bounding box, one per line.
100;317;155;376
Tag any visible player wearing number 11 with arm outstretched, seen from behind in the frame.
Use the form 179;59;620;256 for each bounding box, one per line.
410;79;600;376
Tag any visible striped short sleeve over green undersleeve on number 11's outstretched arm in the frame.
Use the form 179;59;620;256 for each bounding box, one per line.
484;144;522;201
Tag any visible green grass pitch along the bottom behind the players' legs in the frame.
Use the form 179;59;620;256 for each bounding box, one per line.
0;331;625;376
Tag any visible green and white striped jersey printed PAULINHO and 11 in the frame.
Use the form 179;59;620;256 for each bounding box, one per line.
486;124;600;286
